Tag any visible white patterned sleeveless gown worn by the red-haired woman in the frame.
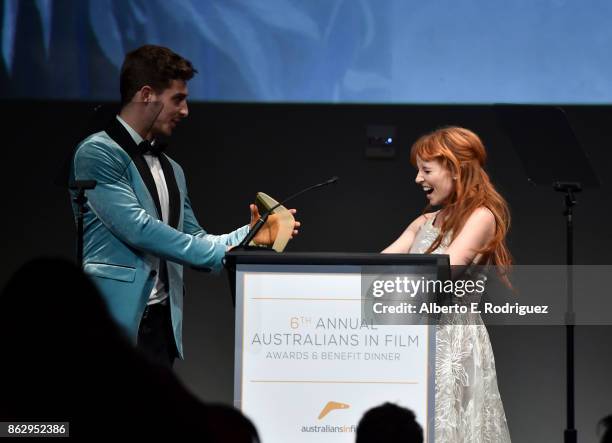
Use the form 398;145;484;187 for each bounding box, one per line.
410;217;510;443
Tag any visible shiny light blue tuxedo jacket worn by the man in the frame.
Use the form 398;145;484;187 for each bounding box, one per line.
70;119;249;358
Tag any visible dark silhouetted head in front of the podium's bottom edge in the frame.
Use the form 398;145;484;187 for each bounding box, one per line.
356;403;423;443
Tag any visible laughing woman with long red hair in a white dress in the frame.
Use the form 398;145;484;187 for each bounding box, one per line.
383;127;512;443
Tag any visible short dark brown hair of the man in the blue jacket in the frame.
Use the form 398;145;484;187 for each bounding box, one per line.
119;45;198;106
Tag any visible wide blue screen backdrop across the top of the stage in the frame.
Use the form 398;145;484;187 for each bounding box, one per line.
0;0;612;104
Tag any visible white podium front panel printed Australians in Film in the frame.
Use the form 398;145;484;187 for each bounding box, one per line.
234;264;435;443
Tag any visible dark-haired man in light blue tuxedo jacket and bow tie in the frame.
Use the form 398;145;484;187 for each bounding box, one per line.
71;45;296;366
